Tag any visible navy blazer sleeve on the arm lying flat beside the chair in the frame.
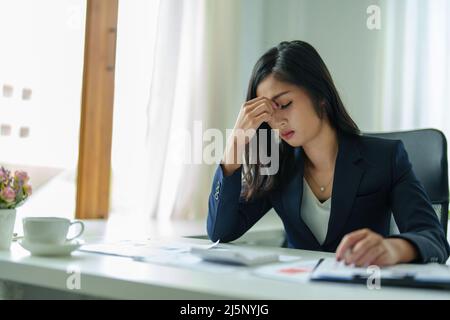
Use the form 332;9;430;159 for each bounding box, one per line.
390;141;450;263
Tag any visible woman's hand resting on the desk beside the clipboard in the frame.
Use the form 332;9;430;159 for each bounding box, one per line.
336;229;417;267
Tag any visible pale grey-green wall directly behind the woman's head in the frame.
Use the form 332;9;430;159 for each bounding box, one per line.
227;0;384;131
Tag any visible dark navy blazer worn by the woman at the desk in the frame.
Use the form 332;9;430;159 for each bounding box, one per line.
207;134;450;263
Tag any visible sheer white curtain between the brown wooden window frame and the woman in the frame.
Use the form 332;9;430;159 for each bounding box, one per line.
112;0;214;220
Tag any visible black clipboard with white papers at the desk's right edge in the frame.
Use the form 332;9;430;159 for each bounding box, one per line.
311;258;450;289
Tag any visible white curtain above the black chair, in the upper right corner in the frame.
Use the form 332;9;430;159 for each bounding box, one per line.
382;0;450;139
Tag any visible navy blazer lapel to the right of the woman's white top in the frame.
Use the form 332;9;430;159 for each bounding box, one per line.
323;134;364;247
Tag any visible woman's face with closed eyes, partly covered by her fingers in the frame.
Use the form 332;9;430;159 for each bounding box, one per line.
256;74;325;147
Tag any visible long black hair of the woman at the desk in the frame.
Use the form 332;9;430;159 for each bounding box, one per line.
243;40;360;200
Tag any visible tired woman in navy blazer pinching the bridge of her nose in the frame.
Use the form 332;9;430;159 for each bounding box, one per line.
207;41;450;266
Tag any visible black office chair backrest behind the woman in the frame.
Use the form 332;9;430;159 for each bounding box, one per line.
364;129;449;235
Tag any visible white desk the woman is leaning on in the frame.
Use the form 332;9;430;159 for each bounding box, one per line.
0;218;450;299
